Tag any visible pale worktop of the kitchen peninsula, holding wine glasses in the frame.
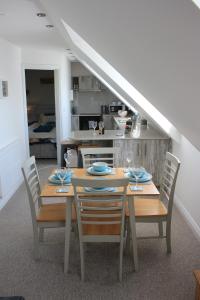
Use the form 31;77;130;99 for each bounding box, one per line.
70;127;169;141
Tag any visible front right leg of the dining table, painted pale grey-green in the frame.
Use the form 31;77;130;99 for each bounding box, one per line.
128;196;138;271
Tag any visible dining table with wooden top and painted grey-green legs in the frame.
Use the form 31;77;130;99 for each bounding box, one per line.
40;168;159;273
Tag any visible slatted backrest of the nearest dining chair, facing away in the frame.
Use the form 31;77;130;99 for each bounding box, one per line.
72;177;128;241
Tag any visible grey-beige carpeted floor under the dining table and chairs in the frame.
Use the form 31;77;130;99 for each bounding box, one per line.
0;164;200;300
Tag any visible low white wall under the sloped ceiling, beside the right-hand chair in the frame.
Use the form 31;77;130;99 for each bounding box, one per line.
173;136;200;239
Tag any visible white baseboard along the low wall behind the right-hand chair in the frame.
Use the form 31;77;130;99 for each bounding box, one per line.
174;196;200;241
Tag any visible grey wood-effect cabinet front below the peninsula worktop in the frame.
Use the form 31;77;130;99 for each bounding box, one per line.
113;139;171;185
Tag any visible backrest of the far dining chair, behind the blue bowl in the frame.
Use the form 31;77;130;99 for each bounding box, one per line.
81;147;118;168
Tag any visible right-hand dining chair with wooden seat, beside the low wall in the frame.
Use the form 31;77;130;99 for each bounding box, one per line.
126;152;180;253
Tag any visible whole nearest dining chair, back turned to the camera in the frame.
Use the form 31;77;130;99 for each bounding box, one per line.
72;178;128;281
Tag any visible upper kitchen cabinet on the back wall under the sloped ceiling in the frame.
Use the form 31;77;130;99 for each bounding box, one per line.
72;75;103;92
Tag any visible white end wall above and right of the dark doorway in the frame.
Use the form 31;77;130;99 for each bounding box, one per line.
22;48;71;162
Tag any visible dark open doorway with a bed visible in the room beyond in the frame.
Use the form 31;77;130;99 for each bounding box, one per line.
25;69;57;163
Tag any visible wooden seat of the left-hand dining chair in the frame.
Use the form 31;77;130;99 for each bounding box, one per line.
37;203;76;222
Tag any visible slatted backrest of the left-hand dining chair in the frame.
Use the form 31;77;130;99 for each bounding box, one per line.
22;156;41;220
